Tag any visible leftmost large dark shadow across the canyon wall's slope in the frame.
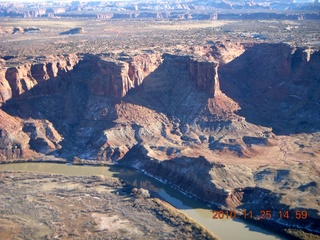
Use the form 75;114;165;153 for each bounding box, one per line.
1;58;118;160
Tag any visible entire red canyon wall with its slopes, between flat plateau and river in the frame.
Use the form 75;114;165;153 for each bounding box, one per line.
0;42;320;233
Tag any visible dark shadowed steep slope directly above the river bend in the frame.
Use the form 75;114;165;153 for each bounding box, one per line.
121;145;228;208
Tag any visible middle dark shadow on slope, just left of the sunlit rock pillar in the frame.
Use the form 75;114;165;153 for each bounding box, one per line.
123;55;212;124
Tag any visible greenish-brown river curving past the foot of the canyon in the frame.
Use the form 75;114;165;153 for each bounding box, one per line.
0;163;284;240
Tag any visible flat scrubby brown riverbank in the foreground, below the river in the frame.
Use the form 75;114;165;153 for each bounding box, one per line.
0;171;218;239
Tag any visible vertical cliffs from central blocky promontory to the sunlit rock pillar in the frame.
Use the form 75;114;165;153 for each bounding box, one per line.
80;53;219;97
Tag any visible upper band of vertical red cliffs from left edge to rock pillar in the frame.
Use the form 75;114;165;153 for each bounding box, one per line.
0;53;219;104
